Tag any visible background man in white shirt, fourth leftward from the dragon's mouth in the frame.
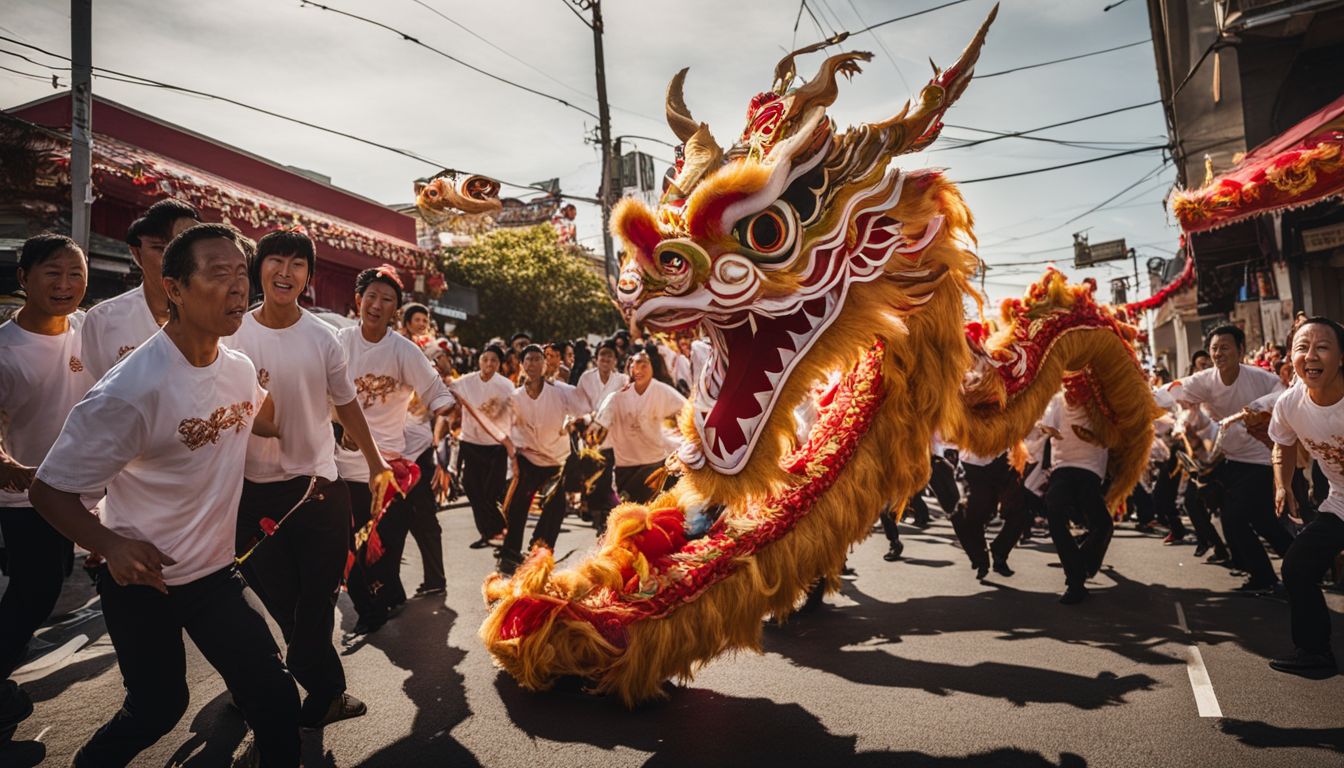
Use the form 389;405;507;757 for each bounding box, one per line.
453;346;513;549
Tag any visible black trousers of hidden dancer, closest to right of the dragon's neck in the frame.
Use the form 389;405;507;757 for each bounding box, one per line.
952;456;1027;568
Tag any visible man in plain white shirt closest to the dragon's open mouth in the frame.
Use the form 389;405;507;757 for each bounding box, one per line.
594;350;685;504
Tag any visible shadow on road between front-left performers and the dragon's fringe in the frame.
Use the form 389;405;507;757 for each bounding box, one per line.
346;599;480;768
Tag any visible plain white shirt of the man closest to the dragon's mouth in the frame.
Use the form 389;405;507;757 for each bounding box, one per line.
597;381;685;467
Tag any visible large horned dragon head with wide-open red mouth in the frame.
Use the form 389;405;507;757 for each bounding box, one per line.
612;5;997;486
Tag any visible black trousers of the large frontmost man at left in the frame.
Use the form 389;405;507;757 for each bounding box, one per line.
75;566;298;768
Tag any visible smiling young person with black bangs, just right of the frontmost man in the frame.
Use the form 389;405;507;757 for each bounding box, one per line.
224;230;388;728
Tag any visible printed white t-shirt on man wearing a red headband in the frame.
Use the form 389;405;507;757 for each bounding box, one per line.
336;325;454;483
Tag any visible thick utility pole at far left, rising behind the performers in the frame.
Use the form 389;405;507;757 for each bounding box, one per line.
70;0;93;253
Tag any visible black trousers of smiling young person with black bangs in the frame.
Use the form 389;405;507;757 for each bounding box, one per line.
237;477;349;721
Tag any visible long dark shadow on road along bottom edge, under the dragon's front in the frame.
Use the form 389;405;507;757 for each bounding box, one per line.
495;673;1087;768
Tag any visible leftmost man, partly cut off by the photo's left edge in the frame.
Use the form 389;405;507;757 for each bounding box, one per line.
0;234;93;745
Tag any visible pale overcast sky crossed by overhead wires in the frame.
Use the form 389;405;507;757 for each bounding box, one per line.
0;0;1177;306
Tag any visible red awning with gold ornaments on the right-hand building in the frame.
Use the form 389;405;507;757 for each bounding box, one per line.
1172;95;1344;233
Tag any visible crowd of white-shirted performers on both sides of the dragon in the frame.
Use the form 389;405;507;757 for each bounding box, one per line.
0;199;1344;765
